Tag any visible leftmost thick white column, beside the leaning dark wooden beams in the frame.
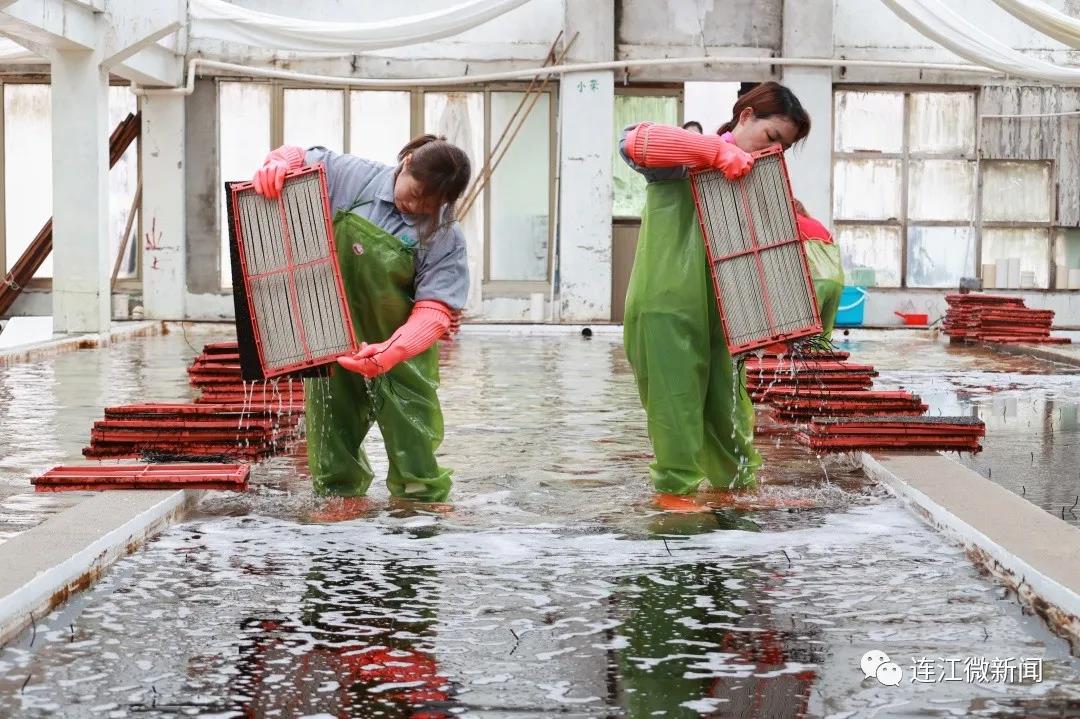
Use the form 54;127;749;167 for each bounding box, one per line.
50;51;112;333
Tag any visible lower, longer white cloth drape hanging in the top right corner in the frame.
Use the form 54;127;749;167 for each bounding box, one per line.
881;0;1080;85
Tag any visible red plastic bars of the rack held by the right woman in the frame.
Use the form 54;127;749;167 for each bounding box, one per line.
690;145;822;354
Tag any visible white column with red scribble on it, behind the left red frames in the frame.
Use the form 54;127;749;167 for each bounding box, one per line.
140;95;187;320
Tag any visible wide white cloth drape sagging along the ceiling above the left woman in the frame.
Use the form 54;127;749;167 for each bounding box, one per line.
190;0;529;53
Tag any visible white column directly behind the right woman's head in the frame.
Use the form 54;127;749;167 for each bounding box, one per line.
783;0;834;226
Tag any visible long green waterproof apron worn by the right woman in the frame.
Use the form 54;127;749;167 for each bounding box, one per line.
623;179;761;494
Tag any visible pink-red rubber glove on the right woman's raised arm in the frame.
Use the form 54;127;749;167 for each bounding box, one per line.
625;122;754;180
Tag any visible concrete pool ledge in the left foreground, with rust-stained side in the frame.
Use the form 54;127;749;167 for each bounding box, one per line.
0;490;198;645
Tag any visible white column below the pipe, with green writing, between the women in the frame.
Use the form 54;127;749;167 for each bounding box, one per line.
558;72;615;322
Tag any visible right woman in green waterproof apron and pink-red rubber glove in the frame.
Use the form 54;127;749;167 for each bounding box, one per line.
619;82;810;508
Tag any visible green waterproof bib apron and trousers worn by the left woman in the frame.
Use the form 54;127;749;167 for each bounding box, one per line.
305;205;451;502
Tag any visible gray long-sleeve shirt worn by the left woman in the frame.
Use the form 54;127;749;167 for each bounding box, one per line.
306;147;469;310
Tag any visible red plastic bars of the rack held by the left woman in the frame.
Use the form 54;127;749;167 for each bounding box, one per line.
230;162;360;379
